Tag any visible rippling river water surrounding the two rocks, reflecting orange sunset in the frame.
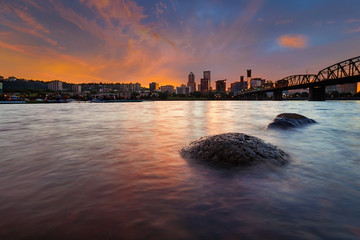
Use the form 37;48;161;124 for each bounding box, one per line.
0;101;360;239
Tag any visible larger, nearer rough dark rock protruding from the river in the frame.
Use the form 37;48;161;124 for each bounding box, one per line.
180;133;288;166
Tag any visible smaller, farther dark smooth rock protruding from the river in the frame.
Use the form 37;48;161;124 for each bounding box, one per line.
268;113;316;129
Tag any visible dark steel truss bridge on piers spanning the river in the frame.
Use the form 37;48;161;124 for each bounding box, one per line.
240;56;360;101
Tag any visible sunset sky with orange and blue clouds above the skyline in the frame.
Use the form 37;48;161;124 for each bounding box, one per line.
0;0;360;86
